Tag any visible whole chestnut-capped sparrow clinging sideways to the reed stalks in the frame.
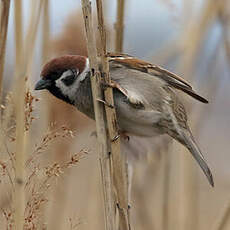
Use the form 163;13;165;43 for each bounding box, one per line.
35;53;214;186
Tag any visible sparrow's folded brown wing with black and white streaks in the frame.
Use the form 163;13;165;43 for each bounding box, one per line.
108;53;208;103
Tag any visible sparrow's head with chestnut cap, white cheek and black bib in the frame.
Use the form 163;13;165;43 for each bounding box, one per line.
35;55;90;104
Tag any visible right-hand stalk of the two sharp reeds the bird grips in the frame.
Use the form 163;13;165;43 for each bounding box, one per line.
96;0;130;230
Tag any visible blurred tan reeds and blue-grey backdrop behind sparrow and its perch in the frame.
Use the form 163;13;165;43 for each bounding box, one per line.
0;0;230;230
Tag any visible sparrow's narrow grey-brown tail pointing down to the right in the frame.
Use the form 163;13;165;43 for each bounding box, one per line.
174;128;214;187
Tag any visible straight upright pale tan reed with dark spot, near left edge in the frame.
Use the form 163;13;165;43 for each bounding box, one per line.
13;0;25;230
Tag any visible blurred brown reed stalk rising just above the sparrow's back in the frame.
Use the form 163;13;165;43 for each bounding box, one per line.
115;0;125;53
